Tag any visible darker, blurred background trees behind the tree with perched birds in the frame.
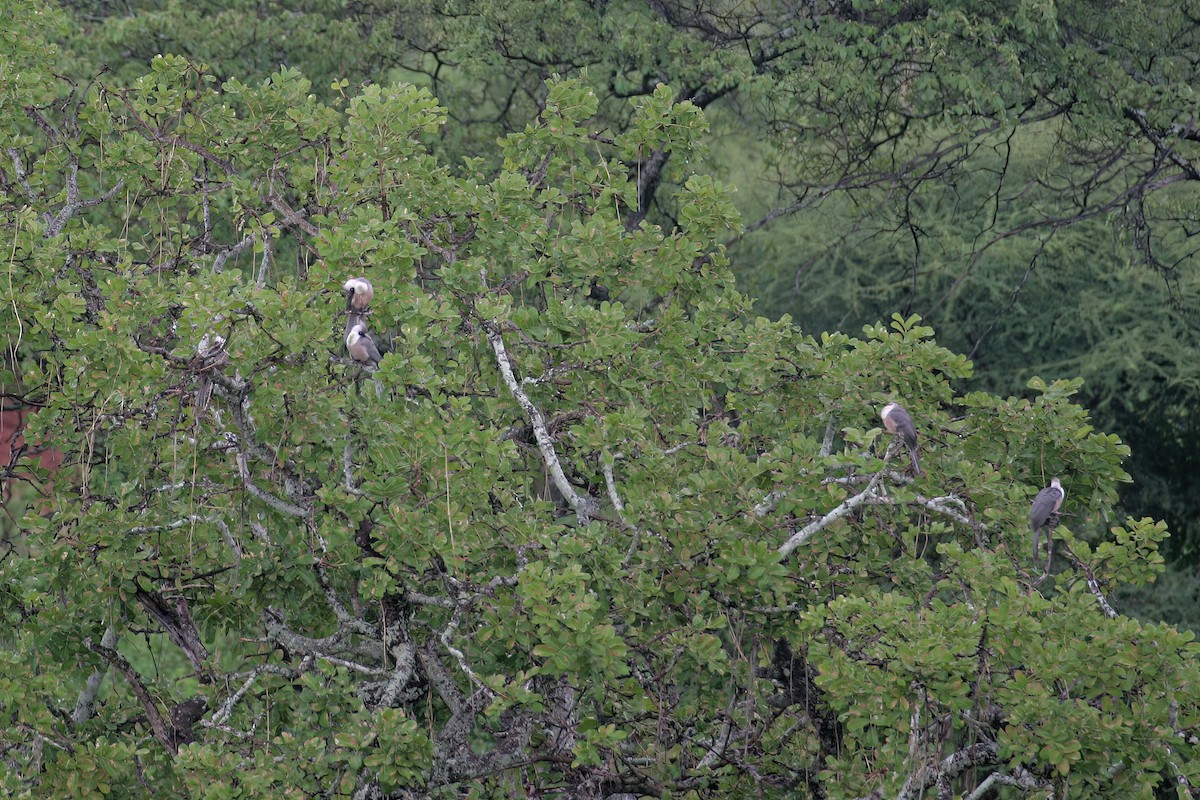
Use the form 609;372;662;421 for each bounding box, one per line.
58;0;1200;563
